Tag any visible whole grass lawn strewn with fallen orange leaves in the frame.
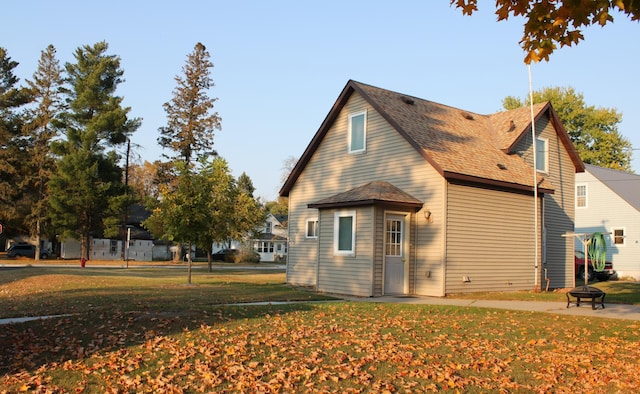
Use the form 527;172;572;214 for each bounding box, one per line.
0;268;640;393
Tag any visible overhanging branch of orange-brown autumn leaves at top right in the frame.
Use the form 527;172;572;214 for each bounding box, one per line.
451;0;640;64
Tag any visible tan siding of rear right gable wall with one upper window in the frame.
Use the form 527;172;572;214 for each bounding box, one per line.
515;116;575;288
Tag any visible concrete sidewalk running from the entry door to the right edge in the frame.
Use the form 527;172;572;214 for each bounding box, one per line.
344;296;640;321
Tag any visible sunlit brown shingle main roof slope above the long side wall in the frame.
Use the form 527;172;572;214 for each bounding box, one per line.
354;83;553;190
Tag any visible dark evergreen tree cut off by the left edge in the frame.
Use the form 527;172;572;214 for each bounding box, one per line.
0;47;31;232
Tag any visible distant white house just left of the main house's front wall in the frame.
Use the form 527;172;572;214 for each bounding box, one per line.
252;213;288;261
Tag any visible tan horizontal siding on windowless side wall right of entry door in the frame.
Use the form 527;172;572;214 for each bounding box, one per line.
445;183;535;294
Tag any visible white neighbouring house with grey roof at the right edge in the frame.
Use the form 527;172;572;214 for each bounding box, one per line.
575;164;640;280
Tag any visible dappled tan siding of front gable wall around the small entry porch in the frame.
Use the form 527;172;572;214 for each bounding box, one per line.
287;93;444;295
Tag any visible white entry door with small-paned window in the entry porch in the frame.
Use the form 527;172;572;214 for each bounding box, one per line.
384;215;405;294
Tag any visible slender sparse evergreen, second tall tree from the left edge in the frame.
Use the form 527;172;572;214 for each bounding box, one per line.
23;45;64;260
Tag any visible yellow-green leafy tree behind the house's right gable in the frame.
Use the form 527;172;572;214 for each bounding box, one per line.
502;87;632;171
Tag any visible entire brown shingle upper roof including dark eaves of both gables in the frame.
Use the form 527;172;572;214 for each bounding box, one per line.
280;81;583;196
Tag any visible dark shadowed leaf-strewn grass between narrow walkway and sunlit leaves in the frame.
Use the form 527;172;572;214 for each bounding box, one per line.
0;302;314;375
